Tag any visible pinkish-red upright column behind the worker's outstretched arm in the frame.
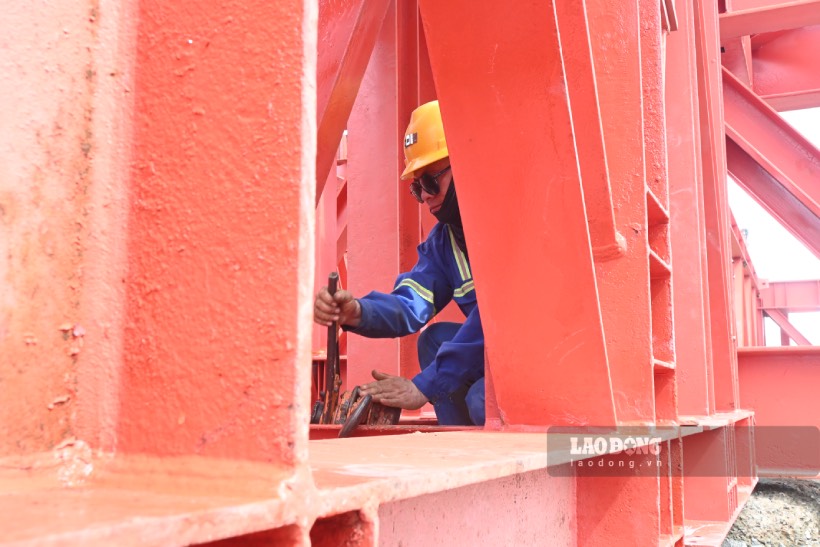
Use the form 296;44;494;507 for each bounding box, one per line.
347;2;403;389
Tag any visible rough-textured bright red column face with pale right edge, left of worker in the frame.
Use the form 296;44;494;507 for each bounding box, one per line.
118;0;317;469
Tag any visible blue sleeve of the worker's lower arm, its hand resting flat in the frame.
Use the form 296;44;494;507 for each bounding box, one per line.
412;306;484;403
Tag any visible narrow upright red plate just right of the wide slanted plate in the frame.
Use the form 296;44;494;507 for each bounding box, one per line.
587;2;659;422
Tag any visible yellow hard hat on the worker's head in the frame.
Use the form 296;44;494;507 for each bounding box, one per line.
401;101;450;180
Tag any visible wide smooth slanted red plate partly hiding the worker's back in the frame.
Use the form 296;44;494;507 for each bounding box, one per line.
419;1;615;425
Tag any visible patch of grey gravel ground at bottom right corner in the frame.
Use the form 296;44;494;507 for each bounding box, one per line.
722;479;820;547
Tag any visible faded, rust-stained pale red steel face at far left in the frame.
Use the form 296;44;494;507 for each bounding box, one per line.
0;1;109;456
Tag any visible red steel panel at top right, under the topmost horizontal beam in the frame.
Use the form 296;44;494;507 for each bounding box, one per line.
752;25;820;110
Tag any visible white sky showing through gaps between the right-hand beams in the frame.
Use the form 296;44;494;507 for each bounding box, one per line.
729;108;820;346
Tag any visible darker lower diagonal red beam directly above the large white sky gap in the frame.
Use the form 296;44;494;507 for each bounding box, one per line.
726;138;820;257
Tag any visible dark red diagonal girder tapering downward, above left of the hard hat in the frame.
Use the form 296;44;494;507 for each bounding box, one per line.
316;0;390;203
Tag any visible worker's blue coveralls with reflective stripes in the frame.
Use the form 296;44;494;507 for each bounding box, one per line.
349;223;484;425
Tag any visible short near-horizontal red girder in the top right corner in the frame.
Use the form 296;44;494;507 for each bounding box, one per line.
720;0;820;42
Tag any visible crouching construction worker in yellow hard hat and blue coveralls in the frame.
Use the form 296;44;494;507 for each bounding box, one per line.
314;101;484;425
